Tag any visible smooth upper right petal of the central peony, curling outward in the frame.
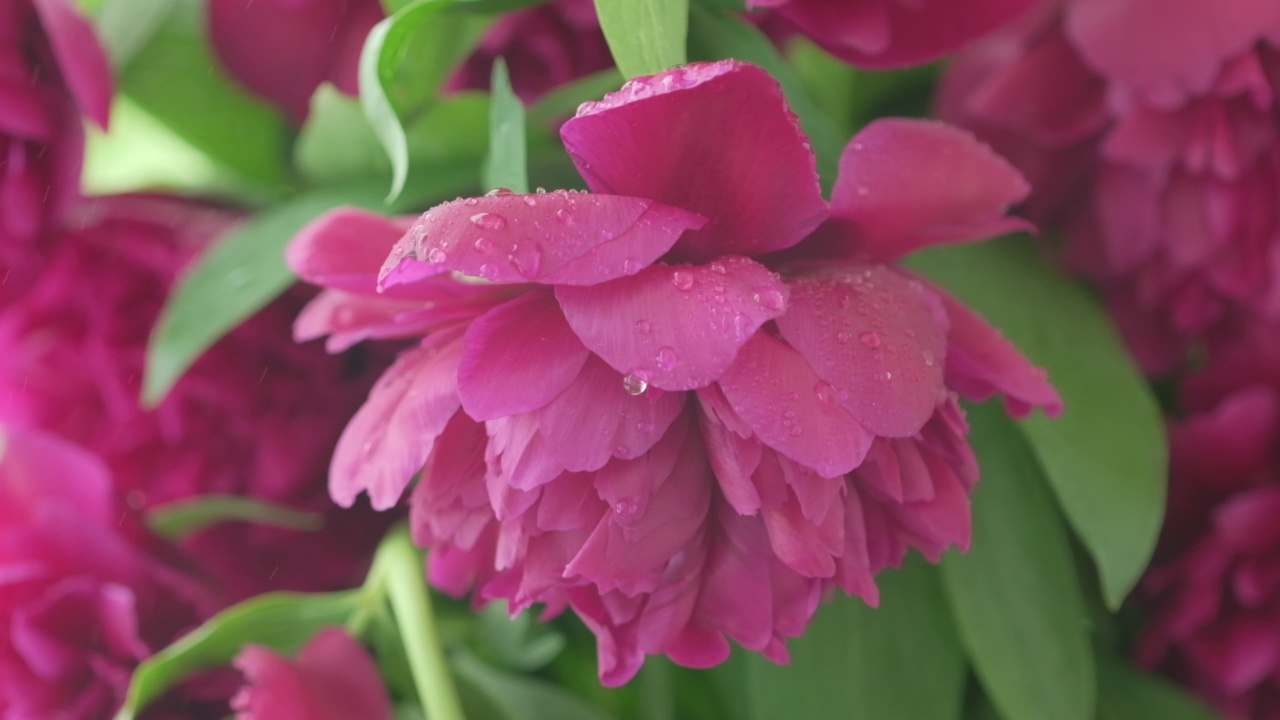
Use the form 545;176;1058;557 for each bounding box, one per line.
831;118;1030;263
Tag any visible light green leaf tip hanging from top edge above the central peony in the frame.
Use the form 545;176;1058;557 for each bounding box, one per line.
595;0;689;78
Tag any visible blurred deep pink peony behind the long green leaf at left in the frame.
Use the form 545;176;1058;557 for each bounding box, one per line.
0;196;388;600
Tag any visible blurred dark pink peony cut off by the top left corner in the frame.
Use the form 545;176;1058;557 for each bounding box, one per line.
0;0;111;301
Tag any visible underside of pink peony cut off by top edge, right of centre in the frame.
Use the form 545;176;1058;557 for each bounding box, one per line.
746;0;1033;68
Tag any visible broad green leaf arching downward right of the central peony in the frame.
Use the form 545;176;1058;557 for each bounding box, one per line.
910;237;1167;609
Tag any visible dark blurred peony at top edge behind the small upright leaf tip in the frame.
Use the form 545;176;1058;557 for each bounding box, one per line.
447;0;613;102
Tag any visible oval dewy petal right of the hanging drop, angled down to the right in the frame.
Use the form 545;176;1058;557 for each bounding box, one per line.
719;333;874;478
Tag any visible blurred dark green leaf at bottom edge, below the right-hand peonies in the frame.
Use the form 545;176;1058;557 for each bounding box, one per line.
1098;651;1219;720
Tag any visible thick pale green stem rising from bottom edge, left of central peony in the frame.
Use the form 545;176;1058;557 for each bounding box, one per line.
374;520;465;720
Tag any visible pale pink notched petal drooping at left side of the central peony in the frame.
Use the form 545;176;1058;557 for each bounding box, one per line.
329;337;462;510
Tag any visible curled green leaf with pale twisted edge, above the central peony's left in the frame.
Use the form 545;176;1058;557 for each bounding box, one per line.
358;0;484;199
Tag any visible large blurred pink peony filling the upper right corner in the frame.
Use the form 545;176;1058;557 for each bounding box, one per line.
940;0;1280;373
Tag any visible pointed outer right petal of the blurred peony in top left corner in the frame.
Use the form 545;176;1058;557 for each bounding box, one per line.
32;0;111;128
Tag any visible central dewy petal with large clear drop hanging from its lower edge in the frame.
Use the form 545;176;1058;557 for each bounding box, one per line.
556;258;787;391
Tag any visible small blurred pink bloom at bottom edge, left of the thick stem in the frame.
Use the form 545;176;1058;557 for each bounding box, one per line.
232;628;392;720
